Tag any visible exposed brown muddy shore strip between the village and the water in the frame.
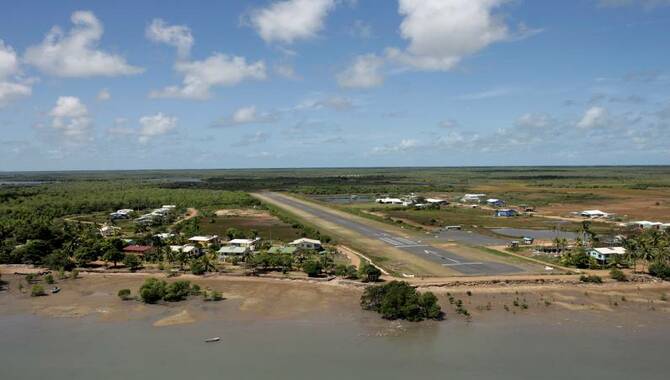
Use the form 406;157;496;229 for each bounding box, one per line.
0;266;670;328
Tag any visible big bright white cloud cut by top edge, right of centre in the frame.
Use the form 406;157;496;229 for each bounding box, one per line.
387;0;511;70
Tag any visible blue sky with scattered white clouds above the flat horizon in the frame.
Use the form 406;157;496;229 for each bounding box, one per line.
0;0;670;171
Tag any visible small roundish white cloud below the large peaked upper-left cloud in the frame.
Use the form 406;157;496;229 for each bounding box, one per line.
49;96;93;140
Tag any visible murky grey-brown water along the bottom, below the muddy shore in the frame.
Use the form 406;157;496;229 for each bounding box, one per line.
0;315;670;380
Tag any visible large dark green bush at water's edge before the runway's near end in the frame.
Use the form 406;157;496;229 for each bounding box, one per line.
361;281;444;321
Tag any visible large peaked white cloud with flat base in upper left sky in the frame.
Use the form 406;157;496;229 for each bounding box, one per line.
25;11;143;77
